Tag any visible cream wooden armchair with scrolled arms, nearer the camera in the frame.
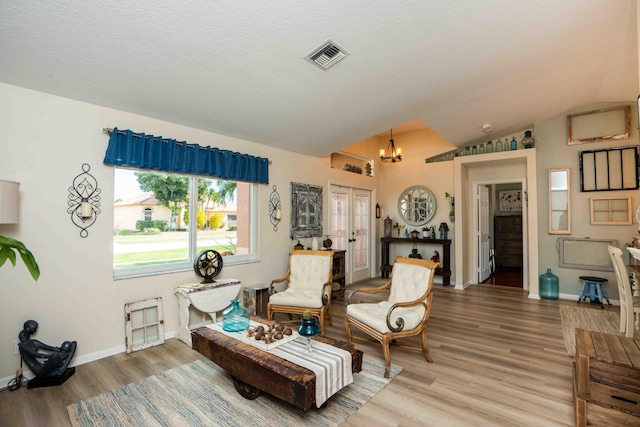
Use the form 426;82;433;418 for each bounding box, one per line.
345;257;440;378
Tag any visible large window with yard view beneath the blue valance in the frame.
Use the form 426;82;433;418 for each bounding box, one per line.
113;168;257;278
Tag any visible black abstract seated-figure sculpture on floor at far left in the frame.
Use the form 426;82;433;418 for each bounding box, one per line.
18;320;77;388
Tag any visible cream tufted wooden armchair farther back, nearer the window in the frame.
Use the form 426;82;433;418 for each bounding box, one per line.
267;250;333;335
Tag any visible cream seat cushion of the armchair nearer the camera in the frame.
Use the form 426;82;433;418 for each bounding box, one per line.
347;301;425;334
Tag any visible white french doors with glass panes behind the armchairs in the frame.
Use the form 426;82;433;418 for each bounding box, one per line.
329;185;371;284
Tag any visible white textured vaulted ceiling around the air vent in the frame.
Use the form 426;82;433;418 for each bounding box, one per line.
0;0;638;156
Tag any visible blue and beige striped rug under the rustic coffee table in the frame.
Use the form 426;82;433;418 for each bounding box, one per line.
67;355;402;427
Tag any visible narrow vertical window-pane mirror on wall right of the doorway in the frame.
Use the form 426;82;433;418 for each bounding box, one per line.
549;169;571;234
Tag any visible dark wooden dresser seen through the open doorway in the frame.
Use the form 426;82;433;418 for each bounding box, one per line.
494;215;522;267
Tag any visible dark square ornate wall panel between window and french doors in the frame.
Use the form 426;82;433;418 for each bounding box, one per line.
289;182;322;239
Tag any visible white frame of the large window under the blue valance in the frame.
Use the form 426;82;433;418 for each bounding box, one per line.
111;171;260;280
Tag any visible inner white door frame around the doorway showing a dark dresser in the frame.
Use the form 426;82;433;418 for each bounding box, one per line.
472;178;529;290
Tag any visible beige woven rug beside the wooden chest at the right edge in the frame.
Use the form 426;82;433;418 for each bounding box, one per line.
560;304;640;357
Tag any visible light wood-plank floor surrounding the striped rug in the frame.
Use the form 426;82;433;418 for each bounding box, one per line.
0;279;575;427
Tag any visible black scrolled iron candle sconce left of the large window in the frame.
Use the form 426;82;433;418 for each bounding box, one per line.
67;163;102;237
